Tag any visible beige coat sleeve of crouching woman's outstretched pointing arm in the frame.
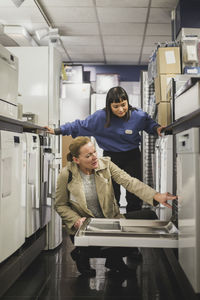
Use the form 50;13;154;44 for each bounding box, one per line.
109;161;157;206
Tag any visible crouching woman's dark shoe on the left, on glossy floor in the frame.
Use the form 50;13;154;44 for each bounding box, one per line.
71;248;96;277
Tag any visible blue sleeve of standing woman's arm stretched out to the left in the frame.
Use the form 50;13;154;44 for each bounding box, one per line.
60;112;100;138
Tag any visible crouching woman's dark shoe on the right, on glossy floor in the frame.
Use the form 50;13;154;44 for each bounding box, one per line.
105;258;135;276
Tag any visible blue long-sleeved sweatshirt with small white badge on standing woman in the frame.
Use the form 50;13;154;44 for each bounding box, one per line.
60;109;160;152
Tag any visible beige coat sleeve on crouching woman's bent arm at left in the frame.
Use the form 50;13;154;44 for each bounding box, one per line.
54;168;81;229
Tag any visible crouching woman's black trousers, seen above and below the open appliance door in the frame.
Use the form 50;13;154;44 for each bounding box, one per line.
70;208;157;264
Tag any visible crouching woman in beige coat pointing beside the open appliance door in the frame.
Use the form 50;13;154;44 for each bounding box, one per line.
55;137;177;276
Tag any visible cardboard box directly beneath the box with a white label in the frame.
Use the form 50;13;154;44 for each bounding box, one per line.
154;74;176;103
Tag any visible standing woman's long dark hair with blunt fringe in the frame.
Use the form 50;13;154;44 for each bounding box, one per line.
104;86;132;128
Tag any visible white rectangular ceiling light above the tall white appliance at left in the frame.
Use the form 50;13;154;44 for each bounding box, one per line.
4;26;38;46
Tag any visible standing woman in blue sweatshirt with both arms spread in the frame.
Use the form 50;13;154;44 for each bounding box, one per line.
45;86;163;212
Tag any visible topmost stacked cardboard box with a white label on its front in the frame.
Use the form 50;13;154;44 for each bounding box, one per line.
156;47;181;75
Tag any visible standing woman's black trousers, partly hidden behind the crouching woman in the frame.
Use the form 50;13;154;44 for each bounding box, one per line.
103;148;142;212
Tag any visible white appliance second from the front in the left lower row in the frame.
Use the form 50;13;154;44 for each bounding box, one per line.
24;132;40;237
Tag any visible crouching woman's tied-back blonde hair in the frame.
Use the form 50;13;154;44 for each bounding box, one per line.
67;136;91;161
